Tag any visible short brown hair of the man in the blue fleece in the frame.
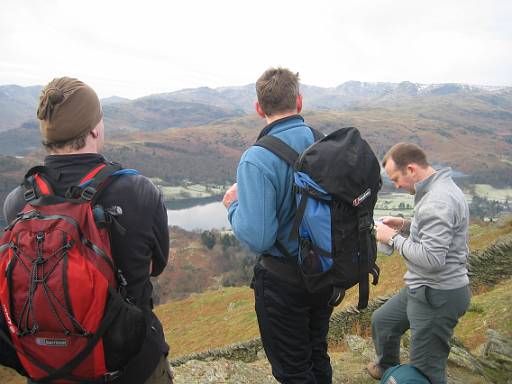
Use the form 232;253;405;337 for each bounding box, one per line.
256;67;299;116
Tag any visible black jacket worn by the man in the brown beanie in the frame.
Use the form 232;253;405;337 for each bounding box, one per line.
4;154;169;384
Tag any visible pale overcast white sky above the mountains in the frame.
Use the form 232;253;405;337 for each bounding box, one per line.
0;0;512;98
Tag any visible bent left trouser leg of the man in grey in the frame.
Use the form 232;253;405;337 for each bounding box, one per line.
372;288;409;371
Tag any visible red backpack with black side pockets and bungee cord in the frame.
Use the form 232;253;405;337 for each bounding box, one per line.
0;163;146;383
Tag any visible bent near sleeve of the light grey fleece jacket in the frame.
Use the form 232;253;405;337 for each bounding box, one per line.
395;201;455;272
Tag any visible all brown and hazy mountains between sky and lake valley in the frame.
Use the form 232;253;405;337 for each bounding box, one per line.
0;81;512;174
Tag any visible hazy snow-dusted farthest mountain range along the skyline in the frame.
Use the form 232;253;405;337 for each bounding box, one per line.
0;81;512;131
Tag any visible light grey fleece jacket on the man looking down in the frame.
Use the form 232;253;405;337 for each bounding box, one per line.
395;168;469;290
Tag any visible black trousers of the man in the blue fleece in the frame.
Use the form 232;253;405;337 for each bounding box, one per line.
252;263;333;384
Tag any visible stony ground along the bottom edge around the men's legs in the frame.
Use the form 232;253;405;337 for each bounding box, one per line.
173;334;512;384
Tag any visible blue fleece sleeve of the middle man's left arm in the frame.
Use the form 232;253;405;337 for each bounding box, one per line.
228;161;278;253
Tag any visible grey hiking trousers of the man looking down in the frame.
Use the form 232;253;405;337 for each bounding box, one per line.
372;286;471;384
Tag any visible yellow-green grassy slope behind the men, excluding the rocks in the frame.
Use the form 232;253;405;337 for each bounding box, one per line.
0;214;512;384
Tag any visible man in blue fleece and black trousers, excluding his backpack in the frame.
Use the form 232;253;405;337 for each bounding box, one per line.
224;68;332;384
